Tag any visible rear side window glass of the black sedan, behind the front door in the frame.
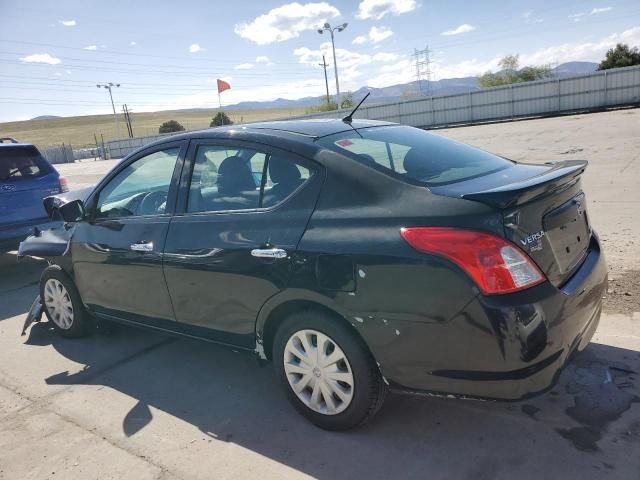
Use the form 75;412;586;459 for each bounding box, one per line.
187;145;312;213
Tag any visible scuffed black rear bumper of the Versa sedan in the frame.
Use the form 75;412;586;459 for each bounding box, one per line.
374;234;607;400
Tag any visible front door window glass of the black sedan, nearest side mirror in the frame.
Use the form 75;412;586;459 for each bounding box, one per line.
96;147;180;218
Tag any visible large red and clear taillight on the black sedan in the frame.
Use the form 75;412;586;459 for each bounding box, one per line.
400;227;544;295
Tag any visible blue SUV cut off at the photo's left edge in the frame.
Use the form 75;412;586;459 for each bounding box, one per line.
0;141;68;253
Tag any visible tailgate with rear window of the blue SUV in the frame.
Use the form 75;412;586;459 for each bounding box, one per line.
0;144;60;227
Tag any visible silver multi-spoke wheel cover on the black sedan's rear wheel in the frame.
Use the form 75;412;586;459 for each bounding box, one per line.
283;330;354;415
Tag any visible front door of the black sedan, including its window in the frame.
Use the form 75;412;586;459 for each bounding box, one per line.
70;142;187;324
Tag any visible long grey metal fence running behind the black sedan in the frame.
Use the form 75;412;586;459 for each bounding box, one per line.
107;66;640;158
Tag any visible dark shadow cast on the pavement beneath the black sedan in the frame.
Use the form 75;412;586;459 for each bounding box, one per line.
25;316;640;479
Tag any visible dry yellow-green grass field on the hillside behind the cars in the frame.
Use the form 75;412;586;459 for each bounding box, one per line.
0;108;305;148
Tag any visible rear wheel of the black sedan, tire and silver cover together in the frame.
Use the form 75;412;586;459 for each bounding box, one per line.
273;310;387;430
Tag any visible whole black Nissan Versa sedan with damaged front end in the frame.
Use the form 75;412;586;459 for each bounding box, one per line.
20;118;607;430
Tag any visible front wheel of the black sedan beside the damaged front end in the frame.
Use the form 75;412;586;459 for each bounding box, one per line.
40;265;93;338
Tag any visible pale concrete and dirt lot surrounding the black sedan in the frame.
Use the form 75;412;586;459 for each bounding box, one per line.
0;110;640;480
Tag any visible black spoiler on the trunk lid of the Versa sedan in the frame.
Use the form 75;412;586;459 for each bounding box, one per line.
462;160;588;208
